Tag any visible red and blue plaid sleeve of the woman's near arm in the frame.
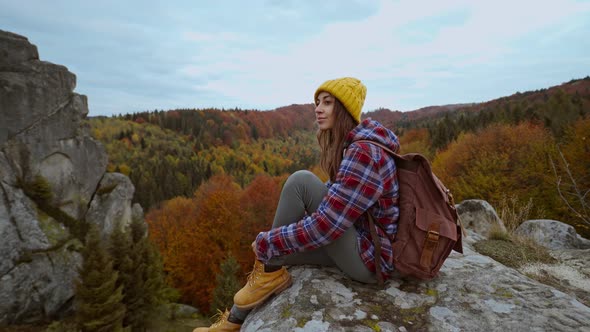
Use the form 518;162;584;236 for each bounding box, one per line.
255;145;383;262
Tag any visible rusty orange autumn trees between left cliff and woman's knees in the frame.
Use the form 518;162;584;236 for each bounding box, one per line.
146;175;282;312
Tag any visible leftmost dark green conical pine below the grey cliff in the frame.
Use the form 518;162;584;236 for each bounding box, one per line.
75;225;125;332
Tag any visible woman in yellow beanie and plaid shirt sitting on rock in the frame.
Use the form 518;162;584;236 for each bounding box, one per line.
195;77;399;331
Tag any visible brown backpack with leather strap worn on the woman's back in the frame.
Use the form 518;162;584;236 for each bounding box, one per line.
356;140;463;284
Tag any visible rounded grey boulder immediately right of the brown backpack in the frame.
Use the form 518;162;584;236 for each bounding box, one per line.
456;199;506;238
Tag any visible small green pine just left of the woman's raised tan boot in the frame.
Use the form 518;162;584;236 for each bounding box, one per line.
211;254;240;312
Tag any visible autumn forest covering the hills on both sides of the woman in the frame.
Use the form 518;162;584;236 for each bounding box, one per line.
89;77;590;313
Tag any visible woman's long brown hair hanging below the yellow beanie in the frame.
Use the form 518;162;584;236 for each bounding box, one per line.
317;98;357;182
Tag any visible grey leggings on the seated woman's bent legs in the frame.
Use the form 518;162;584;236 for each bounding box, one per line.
230;171;377;322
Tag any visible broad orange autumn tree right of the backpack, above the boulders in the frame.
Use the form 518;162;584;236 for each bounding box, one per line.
433;123;560;217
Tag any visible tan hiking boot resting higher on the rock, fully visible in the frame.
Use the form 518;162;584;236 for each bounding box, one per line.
234;260;292;310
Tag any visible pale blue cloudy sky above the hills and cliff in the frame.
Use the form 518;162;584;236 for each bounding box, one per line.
0;0;590;116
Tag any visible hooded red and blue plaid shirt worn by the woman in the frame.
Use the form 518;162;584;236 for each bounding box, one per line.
255;119;399;278
